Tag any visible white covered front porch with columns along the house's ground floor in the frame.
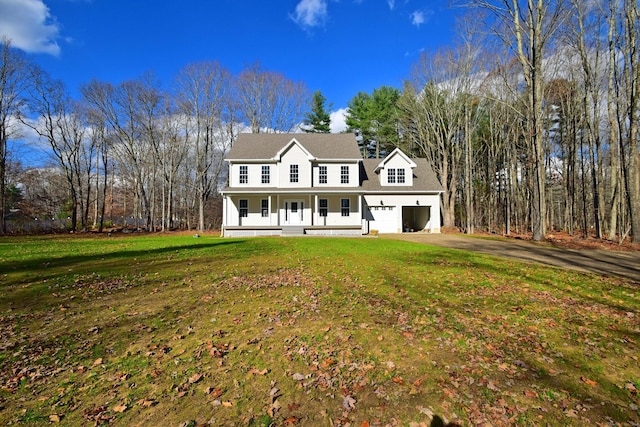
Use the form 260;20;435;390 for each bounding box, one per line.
222;192;363;236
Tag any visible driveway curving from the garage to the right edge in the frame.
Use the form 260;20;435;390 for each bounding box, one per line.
381;233;640;284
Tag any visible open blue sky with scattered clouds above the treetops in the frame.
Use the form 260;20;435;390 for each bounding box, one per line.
0;0;459;131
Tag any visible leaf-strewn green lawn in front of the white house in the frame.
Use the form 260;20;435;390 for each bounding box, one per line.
0;235;640;427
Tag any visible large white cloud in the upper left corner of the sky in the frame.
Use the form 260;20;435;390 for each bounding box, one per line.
0;0;60;55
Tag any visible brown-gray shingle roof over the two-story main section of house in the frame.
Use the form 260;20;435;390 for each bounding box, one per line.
227;133;362;160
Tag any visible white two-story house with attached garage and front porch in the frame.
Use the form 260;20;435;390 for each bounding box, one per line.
222;134;442;236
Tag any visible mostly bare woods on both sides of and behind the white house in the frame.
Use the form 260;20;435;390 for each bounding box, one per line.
0;0;640;243
